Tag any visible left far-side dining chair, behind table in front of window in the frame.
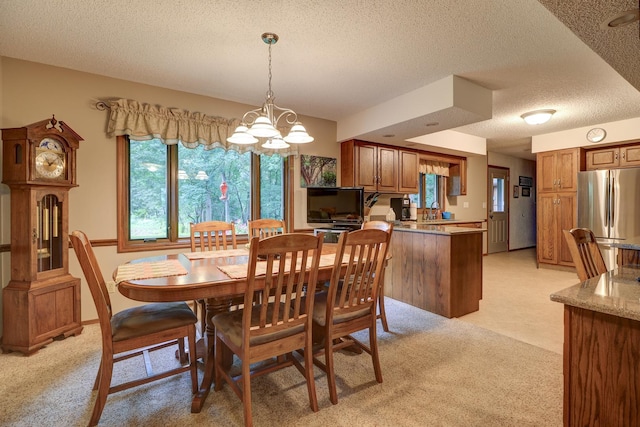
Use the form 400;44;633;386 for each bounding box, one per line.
189;221;240;336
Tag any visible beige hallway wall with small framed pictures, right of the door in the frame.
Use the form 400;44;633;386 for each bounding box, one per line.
488;152;536;250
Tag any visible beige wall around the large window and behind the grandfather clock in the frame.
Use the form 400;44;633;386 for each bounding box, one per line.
0;57;340;332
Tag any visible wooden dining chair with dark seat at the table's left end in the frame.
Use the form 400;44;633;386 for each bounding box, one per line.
69;231;198;426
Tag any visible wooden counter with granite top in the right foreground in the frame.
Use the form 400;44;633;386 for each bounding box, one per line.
551;266;640;426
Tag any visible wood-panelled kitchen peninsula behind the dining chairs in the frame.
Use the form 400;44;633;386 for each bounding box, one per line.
385;223;486;318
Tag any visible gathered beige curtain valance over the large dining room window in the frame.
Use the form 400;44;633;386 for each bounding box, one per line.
98;99;298;157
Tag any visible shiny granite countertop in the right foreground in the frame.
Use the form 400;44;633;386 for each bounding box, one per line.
550;266;640;321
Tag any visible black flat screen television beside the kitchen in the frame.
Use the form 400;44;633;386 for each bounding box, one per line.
307;187;364;225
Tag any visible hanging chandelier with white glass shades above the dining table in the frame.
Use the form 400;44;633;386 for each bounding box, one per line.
227;33;313;149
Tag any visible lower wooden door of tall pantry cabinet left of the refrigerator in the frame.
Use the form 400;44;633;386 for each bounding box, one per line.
537;192;578;266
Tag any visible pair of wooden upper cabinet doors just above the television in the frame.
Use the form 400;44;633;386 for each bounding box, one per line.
340;140;396;193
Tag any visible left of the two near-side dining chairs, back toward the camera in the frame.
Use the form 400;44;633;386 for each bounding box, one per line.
213;233;324;426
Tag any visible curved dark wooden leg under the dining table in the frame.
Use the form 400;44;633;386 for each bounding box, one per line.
191;298;233;413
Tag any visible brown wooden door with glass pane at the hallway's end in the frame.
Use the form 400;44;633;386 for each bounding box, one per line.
487;166;509;254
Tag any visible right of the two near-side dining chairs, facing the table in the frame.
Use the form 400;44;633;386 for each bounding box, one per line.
313;229;391;404
